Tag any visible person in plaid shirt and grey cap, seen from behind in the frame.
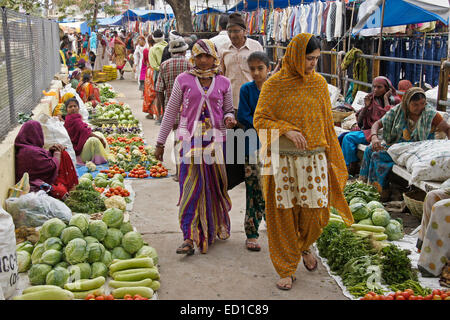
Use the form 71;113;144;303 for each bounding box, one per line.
155;37;191;181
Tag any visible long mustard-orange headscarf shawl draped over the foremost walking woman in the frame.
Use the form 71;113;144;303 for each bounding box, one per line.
253;33;354;225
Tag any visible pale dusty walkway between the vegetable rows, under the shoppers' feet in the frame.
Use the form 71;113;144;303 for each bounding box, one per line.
111;73;347;300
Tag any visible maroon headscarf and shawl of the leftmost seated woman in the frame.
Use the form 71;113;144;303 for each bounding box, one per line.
14;120;58;189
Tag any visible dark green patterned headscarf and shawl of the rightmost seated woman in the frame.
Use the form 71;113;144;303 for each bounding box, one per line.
381;87;437;145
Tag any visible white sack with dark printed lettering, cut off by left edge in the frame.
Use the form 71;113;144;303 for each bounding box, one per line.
0;208;19;300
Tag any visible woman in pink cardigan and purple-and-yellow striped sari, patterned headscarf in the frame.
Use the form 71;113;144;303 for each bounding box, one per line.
155;40;236;255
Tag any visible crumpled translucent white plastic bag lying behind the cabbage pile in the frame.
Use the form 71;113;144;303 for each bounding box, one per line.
5;190;72;228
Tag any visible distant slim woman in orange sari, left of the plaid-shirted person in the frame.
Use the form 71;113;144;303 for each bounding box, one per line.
141;35;162;119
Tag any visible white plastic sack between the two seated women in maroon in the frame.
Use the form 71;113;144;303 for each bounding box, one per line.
38;113;77;167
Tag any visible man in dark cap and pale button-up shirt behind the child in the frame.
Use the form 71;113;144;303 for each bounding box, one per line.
218;12;264;112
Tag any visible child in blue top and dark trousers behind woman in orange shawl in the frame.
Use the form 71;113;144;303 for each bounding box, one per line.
237;51;270;251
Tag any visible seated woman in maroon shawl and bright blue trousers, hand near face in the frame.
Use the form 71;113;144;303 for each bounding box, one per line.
342;77;401;175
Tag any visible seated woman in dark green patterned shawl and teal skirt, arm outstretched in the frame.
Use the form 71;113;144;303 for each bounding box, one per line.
359;87;450;202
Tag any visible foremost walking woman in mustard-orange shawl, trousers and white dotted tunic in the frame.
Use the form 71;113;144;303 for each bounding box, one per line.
253;33;353;290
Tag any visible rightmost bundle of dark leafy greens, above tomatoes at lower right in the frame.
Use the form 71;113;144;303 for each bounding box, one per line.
381;244;418;285
